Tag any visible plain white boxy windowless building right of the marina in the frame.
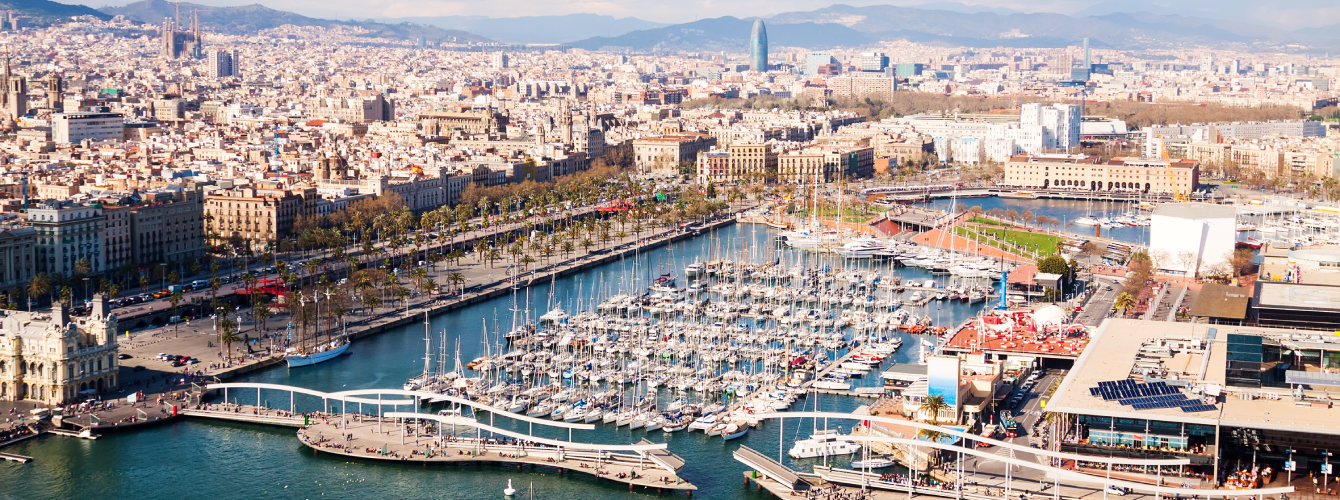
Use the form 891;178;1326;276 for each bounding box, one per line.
1150;204;1237;275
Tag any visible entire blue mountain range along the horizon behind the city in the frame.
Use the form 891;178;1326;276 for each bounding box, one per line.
0;0;1318;51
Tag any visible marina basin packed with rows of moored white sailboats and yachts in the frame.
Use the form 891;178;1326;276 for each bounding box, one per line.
3;193;1248;499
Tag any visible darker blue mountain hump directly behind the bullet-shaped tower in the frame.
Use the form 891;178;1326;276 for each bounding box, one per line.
571;16;876;51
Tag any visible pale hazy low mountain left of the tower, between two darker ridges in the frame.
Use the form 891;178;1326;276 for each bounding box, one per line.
378;13;666;43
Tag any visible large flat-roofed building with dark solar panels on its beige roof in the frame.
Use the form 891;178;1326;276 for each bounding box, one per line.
1045;319;1340;484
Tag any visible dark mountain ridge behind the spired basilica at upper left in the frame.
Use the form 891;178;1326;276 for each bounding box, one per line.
101;0;490;42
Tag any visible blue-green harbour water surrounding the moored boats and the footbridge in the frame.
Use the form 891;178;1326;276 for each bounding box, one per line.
0;222;996;499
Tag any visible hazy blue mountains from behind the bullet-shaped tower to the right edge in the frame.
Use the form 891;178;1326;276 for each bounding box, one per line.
572;4;1321;51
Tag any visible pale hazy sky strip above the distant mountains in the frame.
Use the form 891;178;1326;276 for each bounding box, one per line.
78;0;1340;29
